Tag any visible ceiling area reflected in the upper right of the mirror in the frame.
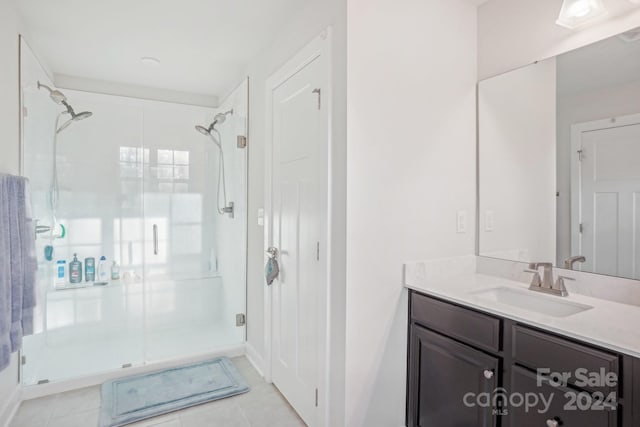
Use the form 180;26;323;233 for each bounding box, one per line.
557;30;640;95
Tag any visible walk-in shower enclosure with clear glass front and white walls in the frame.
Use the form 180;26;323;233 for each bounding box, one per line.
21;43;248;385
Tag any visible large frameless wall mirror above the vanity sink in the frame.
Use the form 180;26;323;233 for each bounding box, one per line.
478;29;640;279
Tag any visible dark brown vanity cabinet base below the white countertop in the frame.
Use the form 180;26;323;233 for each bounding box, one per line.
407;291;640;427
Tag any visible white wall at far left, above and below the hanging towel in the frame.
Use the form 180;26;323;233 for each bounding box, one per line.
0;0;21;425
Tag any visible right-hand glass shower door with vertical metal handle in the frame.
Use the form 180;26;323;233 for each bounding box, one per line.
144;98;246;362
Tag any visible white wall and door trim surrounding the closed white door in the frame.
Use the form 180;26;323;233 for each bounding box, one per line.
242;0;346;426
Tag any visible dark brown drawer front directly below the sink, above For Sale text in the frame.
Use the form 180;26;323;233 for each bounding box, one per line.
513;326;621;393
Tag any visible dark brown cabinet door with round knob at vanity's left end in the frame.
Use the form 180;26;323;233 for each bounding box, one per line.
407;325;500;427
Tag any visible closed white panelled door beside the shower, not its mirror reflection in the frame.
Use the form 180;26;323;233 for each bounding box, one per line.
271;49;328;426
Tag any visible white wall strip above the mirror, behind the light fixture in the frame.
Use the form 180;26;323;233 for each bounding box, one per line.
478;0;640;80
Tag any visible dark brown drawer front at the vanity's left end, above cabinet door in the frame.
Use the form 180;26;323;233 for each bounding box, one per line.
411;292;502;351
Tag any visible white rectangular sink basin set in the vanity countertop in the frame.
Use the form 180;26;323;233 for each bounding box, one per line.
472;287;593;317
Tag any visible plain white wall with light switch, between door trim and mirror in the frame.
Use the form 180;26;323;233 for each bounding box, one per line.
346;0;477;427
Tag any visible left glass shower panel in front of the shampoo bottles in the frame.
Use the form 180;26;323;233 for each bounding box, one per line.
21;45;144;385
